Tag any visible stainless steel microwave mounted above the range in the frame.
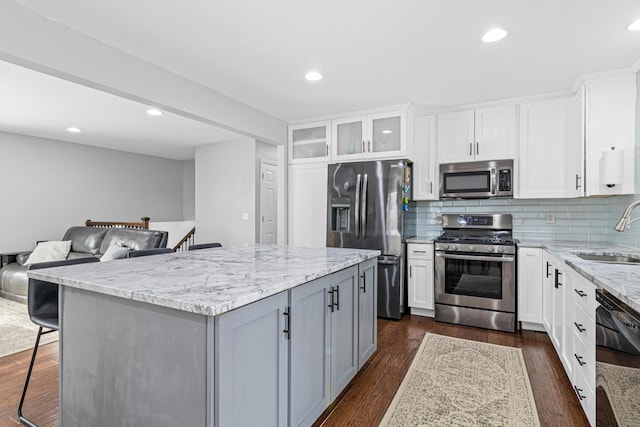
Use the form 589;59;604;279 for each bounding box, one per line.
440;160;513;199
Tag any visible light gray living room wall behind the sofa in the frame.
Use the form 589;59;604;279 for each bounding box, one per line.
0;132;183;252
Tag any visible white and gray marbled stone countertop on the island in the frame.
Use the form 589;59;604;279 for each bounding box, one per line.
27;245;380;316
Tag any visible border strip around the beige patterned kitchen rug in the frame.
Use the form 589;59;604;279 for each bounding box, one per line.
379;332;540;427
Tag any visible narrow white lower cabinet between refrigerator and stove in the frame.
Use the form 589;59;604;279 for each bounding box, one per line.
407;243;435;317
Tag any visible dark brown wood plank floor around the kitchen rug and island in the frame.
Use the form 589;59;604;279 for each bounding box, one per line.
0;316;588;427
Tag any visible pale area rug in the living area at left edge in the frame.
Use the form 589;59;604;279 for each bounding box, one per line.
0;298;58;357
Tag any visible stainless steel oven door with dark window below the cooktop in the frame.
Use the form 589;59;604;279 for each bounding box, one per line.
435;251;516;313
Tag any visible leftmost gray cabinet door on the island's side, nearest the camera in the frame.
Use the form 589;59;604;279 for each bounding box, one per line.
214;291;289;426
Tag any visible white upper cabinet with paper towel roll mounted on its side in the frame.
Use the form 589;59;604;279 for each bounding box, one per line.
584;72;636;196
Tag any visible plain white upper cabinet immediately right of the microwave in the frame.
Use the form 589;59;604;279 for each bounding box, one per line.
516;97;582;199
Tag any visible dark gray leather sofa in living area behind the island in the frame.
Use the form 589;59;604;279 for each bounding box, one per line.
0;226;168;304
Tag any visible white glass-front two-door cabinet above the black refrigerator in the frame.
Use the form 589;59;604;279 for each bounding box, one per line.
331;111;407;162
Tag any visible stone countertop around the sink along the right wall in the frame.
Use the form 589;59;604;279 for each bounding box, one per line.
518;240;640;312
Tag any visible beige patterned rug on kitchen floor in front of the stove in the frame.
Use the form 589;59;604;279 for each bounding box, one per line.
380;334;540;427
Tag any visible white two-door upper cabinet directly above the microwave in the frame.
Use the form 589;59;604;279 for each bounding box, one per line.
438;104;516;163
